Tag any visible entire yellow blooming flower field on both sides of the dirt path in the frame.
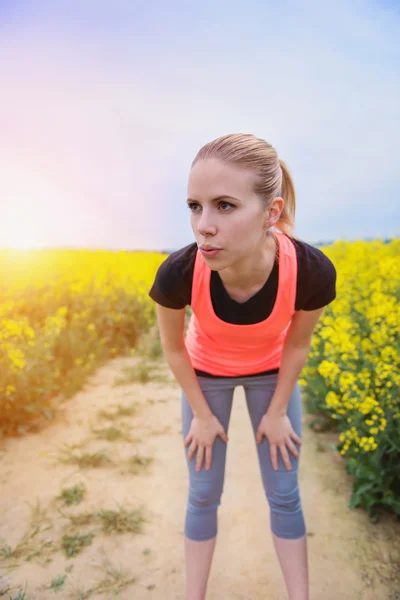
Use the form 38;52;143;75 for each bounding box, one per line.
0;239;400;516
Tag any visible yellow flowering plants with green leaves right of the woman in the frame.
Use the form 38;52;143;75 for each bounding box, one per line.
300;239;400;516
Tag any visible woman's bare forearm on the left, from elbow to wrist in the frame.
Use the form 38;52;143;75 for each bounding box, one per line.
164;347;212;417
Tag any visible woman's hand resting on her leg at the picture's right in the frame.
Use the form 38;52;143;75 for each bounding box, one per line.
256;411;302;471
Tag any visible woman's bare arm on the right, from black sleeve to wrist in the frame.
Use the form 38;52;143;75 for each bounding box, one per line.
267;306;325;415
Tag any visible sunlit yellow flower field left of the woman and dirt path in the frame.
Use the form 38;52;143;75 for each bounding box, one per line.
0;250;165;435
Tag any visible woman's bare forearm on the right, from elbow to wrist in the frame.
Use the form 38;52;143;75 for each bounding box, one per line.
268;339;311;414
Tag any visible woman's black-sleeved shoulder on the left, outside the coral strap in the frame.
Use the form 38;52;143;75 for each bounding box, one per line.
149;242;197;309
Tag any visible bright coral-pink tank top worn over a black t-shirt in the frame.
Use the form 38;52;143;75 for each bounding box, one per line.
185;230;297;377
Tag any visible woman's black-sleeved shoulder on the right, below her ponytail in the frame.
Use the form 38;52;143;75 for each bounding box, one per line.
284;237;337;310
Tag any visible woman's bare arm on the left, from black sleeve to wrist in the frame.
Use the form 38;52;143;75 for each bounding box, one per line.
156;303;213;418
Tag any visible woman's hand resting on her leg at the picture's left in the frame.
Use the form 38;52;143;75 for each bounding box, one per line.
185;414;229;471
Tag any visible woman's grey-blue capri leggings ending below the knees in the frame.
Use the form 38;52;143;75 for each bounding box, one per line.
181;373;305;541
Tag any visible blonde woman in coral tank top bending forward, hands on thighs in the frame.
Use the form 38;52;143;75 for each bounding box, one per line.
149;134;336;600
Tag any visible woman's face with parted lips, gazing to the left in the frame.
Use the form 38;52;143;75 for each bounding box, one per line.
187;158;283;270
